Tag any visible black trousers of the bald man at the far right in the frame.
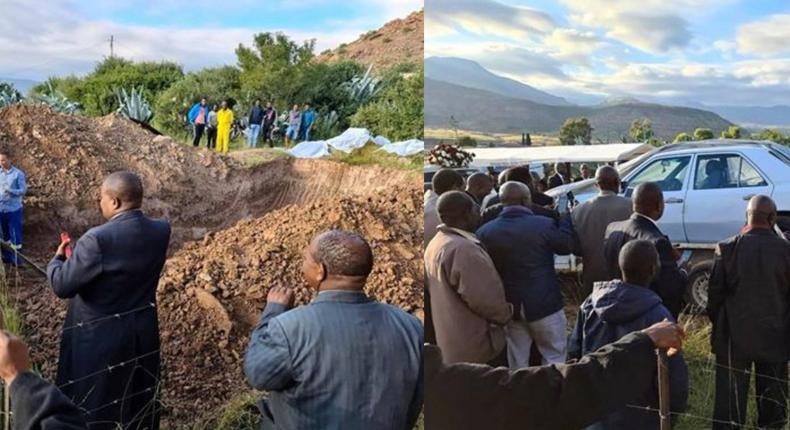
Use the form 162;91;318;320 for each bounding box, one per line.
713;354;787;430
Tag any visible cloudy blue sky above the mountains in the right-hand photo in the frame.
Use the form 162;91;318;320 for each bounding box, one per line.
425;0;790;106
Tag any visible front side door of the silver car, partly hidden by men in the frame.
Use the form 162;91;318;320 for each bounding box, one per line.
625;155;691;243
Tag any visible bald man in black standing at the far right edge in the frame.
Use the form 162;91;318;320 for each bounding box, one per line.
707;195;790;429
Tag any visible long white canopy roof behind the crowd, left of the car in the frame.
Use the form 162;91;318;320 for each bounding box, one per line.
471;143;654;167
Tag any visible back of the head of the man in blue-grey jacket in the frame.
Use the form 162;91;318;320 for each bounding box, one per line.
313;230;373;277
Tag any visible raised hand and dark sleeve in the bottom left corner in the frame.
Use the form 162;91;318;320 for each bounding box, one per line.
0;331;86;430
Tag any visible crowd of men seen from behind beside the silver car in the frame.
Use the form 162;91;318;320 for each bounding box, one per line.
424;164;790;430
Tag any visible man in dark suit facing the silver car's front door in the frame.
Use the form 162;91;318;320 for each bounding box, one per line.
604;182;688;319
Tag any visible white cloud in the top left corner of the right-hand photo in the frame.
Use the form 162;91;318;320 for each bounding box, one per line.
425;0;555;39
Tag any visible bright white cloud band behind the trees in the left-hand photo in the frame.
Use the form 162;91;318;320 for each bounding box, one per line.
0;0;406;80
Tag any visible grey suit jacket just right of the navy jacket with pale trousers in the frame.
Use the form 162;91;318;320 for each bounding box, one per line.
571;191;633;295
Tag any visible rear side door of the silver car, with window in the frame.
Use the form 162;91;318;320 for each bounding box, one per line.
684;152;773;243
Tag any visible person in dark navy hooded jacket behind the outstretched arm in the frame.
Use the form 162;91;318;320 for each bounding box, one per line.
568;239;689;430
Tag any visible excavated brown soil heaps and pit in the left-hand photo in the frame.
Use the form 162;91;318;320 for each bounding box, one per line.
0;105;422;423
